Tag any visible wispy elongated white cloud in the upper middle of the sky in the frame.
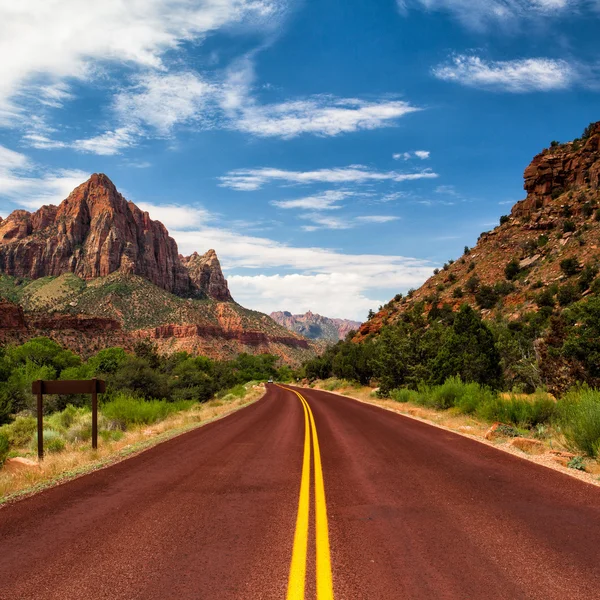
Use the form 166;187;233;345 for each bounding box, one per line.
233;96;420;138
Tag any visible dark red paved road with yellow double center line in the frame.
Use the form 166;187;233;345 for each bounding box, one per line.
0;385;600;600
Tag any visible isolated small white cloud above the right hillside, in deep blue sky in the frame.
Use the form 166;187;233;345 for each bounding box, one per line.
433;55;579;93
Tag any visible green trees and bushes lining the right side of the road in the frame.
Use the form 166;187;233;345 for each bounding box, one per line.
303;300;600;458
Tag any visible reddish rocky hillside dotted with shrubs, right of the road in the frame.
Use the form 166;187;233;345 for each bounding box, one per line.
355;123;600;341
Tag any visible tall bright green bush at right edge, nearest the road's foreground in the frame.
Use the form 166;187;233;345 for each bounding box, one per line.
558;387;600;456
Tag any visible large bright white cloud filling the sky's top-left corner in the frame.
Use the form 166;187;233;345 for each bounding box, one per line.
0;0;282;120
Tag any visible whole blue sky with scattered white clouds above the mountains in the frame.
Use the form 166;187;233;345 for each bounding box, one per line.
0;0;600;319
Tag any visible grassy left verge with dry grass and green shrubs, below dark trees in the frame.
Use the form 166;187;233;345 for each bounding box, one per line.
0;382;265;506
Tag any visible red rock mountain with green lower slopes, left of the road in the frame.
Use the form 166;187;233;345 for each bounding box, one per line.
0;175;313;364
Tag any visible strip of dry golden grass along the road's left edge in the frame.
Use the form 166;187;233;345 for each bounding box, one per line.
0;386;264;505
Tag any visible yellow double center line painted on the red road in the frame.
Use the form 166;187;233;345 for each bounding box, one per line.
279;386;333;600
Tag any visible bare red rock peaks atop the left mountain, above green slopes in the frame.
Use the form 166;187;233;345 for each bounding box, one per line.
0;174;231;300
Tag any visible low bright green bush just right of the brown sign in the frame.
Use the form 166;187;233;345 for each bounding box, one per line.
101;394;195;430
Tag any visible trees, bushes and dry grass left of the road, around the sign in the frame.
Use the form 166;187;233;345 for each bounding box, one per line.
0;338;292;498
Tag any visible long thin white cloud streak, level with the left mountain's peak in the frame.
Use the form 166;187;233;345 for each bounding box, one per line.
220;165;438;191
